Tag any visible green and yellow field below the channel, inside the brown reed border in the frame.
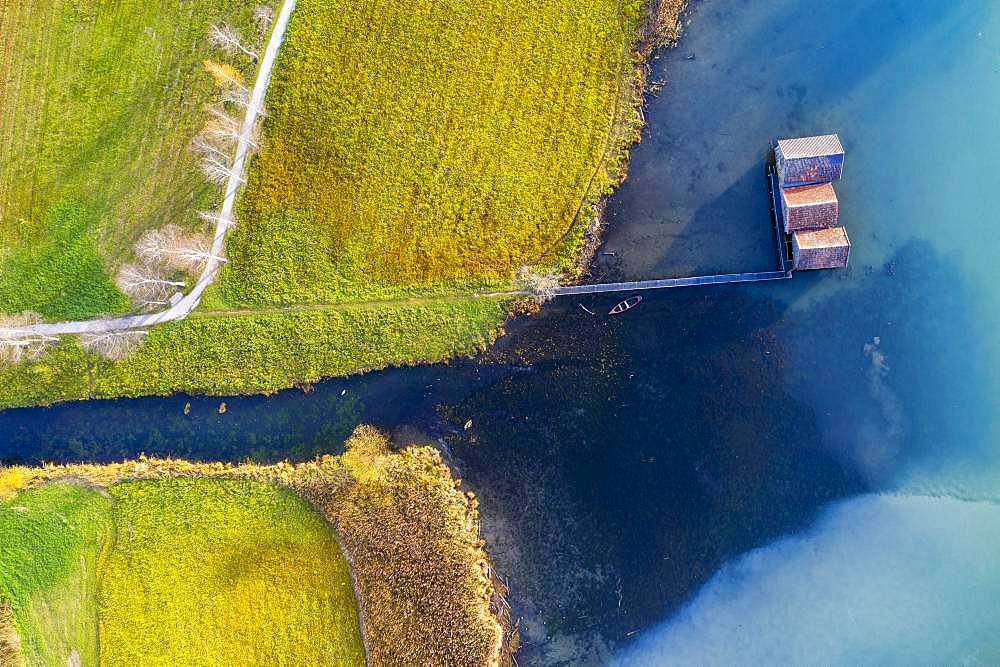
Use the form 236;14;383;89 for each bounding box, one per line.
0;478;364;665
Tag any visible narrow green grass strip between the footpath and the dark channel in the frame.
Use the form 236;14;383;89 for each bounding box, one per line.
0;299;509;409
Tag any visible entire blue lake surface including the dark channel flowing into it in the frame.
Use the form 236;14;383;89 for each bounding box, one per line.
0;0;1000;665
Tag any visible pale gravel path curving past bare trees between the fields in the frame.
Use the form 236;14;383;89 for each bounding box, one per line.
18;0;296;335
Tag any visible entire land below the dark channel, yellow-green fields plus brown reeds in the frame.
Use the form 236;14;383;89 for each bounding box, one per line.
0;426;511;667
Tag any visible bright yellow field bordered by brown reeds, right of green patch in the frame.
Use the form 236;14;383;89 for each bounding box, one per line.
100;479;364;667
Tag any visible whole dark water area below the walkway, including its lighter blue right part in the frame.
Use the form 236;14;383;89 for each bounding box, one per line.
444;230;989;664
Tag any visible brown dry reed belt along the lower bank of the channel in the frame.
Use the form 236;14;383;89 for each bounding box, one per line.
0;426;512;666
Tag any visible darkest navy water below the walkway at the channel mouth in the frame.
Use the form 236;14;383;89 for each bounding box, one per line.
445;287;863;664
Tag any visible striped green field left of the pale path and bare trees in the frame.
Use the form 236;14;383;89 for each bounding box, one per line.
0;0;256;318
